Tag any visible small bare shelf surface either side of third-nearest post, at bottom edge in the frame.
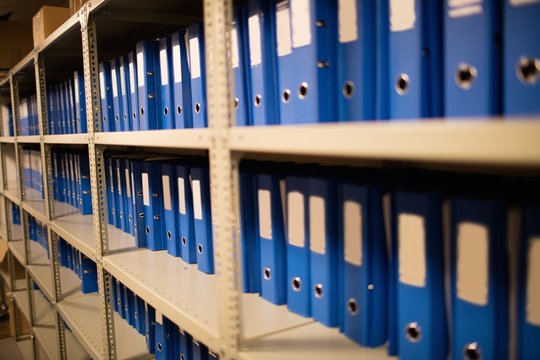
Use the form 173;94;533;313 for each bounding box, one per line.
34;326;90;360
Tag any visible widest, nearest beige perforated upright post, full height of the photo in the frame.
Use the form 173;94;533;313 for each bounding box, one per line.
204;0;241;359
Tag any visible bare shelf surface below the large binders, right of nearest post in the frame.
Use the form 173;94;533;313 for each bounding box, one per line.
239;322;388;360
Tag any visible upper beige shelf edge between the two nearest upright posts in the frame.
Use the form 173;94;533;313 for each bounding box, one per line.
95;129;210;150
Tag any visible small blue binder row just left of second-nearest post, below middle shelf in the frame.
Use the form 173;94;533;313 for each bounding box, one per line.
58;237;98;294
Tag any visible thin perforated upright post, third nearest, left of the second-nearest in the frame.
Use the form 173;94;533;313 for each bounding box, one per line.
30;52;67;360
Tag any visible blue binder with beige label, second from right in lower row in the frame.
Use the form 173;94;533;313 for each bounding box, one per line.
451;197;508;359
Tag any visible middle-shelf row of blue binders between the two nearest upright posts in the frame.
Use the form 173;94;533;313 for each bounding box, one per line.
105;154;214;274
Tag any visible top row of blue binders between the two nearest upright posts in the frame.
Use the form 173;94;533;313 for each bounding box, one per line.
99;23;207;131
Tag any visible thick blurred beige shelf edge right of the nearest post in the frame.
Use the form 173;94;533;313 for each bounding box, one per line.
230;118;540;166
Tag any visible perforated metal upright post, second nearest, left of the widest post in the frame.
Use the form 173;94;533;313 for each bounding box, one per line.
79;1;117;360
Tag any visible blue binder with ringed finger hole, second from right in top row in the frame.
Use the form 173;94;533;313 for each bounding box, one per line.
444;0;503;116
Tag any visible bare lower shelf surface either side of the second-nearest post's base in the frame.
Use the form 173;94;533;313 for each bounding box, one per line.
57;293;150;359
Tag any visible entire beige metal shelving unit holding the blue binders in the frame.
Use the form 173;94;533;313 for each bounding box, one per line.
0;0;540;360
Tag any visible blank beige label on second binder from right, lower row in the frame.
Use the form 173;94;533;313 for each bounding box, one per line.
457;222;489;305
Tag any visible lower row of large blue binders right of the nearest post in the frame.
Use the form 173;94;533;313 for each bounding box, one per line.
240;162;540;359
